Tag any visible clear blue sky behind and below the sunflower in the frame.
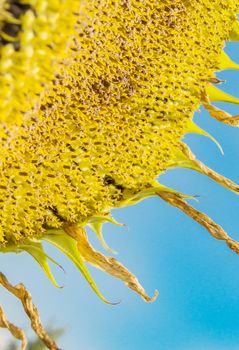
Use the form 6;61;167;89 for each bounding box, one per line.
0;43;239;350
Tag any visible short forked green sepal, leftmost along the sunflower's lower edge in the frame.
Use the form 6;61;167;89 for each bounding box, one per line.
20;241;62;288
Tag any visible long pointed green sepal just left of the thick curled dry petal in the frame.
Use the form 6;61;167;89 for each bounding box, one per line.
43;230;113;304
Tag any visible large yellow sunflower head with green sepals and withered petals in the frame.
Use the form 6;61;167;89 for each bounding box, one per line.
0;0;239;302
